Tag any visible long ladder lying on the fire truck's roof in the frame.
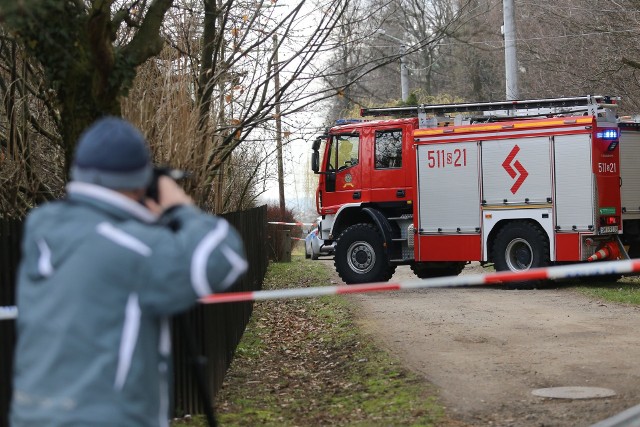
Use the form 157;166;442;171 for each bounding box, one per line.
360;95;620;128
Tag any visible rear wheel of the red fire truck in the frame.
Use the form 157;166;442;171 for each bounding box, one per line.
491;221;551;289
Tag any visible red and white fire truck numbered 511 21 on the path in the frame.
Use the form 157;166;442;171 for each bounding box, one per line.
311;95;628;284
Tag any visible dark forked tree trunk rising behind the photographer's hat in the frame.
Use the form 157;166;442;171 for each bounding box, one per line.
0;0;172;172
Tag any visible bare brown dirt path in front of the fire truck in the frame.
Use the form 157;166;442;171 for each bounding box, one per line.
324;260;640;427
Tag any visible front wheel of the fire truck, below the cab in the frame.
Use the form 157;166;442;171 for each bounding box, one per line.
334;224;395;285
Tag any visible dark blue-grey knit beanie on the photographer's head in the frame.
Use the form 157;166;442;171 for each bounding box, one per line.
71;117;153;190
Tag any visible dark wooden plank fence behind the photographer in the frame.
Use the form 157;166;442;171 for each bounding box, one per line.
0;206;269;427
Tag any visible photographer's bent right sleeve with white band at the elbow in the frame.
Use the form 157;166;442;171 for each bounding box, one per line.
140;206;248;314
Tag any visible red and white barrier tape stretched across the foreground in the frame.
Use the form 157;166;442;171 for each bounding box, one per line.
0;259;640;320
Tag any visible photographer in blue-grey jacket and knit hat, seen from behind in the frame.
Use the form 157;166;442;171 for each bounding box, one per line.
10;117;247;427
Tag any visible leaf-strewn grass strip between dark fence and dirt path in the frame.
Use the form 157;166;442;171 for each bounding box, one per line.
208;255;446;426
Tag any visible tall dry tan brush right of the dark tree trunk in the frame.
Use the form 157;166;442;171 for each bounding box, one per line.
122;50;259;213
